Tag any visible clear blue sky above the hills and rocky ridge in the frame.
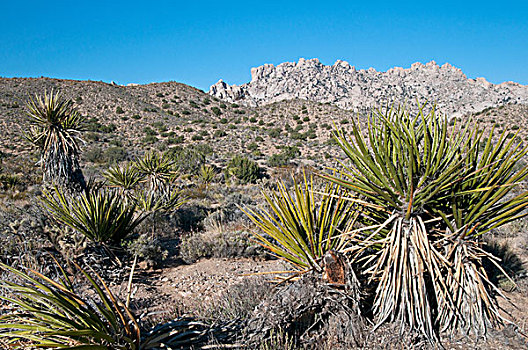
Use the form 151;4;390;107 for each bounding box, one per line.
0;0;528;90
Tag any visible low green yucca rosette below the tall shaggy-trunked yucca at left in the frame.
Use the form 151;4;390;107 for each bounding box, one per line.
42;187;145;243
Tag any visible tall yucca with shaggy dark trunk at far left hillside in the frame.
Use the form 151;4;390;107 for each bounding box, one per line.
25;92;85;191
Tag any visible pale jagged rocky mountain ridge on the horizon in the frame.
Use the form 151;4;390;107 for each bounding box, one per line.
209;58;528;116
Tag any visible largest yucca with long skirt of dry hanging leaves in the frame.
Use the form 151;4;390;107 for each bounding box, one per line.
325;106;528;341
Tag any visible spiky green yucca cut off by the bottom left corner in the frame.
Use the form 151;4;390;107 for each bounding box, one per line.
0;264;140;350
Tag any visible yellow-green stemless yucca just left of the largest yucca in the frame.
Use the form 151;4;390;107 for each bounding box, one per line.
245;174;358;272
